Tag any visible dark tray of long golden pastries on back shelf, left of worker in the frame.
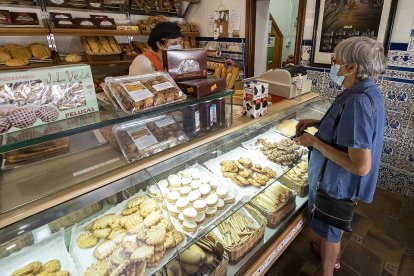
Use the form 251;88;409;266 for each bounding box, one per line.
81;36;122;61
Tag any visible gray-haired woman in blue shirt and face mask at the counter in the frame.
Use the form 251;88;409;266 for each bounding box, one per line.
295;37;385;275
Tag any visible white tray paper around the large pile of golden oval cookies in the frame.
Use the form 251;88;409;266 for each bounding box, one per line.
69;190;186;275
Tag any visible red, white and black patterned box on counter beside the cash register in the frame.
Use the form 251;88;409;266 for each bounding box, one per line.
243;80;269;118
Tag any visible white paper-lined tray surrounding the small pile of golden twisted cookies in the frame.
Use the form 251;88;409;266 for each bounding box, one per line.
204;147;284;202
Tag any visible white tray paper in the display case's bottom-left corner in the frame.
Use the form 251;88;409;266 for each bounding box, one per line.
0;229;81;275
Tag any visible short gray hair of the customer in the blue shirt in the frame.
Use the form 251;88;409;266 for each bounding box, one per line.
335;36;386;80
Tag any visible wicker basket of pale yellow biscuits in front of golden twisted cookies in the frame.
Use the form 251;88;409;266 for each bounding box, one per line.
251;182;296;228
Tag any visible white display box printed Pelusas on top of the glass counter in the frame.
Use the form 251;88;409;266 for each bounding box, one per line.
0;64;98;133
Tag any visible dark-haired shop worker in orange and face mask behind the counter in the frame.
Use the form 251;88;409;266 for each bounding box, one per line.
129;22;183;75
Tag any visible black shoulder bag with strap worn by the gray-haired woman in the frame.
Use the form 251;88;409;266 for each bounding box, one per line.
312;102;359;232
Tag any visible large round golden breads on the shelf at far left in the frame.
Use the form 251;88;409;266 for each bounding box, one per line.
0;43;52;66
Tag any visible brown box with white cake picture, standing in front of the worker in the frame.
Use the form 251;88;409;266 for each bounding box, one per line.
162;49;207;81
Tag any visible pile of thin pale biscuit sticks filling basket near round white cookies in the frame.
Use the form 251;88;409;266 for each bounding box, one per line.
218;211;258;247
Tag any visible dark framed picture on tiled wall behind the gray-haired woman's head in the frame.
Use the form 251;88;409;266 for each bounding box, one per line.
311;0;398;67
